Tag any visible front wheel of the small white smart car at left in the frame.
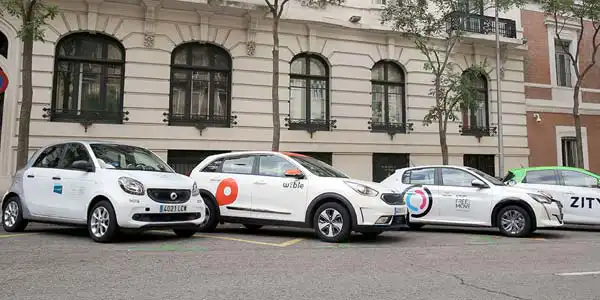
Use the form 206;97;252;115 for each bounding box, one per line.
88;200;119;243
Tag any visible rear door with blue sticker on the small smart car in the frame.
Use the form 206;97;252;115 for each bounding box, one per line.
23;144;64;217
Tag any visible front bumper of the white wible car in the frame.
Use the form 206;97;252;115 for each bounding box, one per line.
353;205;407;232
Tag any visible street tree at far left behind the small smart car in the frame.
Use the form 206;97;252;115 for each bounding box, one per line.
0;0;57;169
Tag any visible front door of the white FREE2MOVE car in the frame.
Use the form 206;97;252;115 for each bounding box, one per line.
437;167;493;225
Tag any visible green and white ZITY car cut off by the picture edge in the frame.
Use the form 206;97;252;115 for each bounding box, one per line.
504;166;600;225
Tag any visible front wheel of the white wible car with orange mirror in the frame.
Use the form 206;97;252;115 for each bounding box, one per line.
313;202;352;243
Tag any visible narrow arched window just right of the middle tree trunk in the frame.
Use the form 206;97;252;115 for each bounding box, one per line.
289;53;330;130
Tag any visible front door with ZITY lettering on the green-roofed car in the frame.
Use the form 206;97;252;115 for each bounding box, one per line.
559;170;600;224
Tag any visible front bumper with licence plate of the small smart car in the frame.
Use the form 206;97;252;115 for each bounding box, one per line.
116;196;206;229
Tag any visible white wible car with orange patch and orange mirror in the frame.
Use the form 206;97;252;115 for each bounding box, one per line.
190;151;407;242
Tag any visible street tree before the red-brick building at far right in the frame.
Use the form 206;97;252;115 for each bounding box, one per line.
537;0;600;168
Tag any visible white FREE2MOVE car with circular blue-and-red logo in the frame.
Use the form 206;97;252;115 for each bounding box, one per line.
381;165;563;237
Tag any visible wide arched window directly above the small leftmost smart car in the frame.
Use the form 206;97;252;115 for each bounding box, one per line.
50;32;125;123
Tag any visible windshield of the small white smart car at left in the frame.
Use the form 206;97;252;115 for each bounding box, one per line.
90;143;174;173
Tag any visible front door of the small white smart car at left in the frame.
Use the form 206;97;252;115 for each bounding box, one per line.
56;143;96;221
